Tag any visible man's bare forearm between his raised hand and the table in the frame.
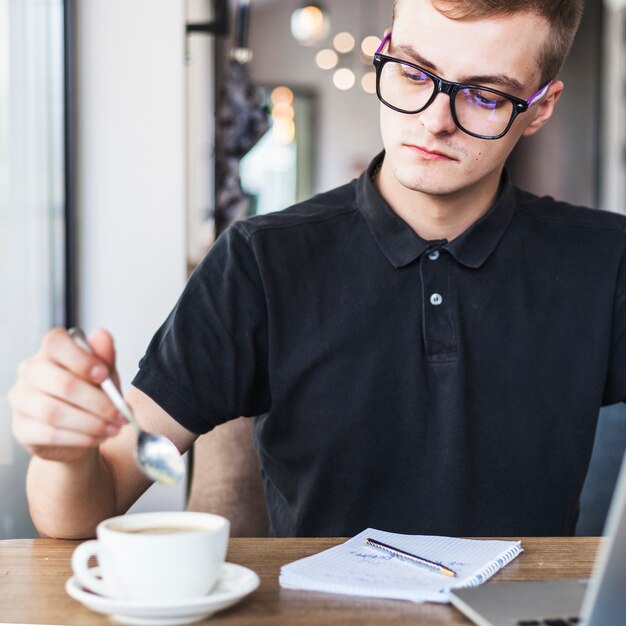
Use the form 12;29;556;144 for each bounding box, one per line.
26;448;118;539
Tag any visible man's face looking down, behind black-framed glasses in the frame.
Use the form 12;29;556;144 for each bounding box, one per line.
381;0;560;195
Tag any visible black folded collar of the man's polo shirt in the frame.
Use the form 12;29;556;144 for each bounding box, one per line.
356;152;515;268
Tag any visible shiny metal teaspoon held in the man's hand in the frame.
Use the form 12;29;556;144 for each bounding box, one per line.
68;328;185;485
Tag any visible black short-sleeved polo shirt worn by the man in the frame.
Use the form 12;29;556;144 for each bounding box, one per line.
134;156;626;536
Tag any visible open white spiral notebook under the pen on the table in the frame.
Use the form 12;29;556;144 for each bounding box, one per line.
279;528;522;602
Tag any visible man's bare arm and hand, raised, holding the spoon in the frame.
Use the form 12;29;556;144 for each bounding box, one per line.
9;329;196;538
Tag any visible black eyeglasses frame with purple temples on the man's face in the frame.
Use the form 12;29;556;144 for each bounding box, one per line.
372;32;554;140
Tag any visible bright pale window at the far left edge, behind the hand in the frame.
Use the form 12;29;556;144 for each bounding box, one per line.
0;0;65;539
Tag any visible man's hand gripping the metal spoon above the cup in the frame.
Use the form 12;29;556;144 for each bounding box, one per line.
8;328;126;463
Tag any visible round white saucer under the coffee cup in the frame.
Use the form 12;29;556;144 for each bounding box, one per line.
65;563;260;626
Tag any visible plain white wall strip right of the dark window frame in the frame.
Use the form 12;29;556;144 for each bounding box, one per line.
75;0;186;509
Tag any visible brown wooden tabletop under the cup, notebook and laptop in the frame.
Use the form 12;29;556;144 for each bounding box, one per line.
0;537;600;626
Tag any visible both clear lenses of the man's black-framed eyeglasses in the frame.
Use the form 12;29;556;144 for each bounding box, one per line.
379;61;514;137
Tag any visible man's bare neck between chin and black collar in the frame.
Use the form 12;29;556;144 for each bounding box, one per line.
374;161;500;241
